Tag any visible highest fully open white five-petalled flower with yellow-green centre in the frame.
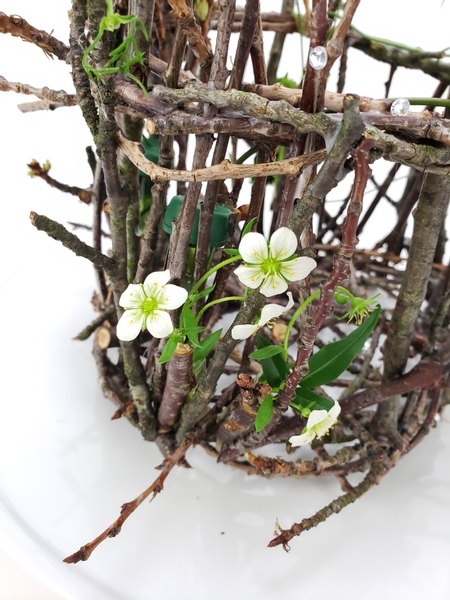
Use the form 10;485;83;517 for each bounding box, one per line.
235;227;316;296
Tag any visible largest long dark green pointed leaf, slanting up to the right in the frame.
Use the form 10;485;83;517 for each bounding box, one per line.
300;304;381;388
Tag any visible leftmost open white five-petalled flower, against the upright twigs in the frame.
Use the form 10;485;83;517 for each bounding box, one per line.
117;269;188;342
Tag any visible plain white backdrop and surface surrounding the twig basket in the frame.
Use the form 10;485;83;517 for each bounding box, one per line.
0;0;450;600
